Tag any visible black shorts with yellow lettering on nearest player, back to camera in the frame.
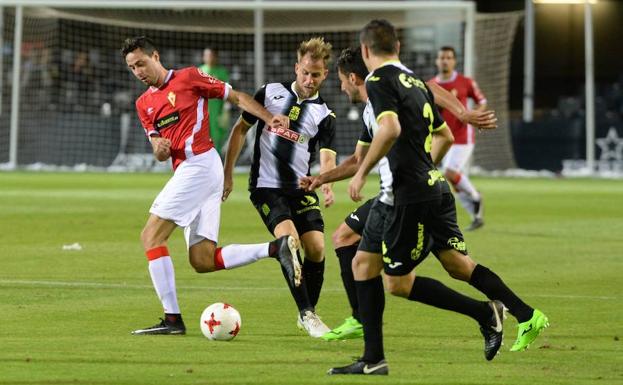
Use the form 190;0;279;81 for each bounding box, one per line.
383;193;467;275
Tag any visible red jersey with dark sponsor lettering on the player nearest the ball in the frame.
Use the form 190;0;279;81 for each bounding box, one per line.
136;67;230;170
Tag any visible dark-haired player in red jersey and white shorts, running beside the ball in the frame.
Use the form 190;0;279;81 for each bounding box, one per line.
121;37;301;334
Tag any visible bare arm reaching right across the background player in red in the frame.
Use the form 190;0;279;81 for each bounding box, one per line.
426;81;498;130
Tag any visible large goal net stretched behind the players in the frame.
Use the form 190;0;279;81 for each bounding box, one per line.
0;1;520;170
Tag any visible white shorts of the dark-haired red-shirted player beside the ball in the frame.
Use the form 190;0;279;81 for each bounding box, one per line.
149;149;223;248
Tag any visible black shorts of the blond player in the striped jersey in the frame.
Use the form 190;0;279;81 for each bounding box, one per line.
251;188;324;235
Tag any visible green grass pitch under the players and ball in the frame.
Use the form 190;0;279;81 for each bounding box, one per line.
0;173;623;385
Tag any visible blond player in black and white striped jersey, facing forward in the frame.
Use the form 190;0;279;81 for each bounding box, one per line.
223;38;336;338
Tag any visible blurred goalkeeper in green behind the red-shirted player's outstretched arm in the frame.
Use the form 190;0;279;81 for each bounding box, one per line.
199;47;229;156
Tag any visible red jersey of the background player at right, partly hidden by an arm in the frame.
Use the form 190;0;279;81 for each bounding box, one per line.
431;71;487;144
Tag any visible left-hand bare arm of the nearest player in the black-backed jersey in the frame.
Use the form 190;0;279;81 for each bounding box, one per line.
348;113;401;202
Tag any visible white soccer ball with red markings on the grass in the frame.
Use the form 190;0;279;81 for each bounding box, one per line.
200;302;242;341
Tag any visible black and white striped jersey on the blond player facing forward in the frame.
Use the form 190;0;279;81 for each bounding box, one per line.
242;83;335;189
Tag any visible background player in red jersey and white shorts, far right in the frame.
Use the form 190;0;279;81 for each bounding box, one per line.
430;46;487;231
